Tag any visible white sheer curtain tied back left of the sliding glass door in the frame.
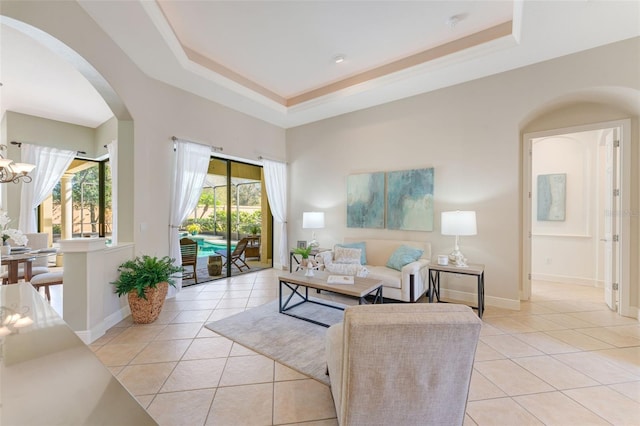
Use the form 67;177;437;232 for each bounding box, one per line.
167;142;211;297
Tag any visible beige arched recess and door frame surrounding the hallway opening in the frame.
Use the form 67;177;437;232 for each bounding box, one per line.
520;88;640;316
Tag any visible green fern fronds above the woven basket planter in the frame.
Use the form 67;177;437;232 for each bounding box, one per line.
111;255;183;300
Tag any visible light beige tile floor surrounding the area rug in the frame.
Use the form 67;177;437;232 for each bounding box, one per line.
51;270;640;426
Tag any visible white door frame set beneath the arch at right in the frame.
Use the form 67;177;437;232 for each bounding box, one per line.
520;119;638;317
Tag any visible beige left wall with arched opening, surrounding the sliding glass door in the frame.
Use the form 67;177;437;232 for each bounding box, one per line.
2;1;285;255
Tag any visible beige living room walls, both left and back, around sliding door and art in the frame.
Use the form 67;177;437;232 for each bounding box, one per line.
2;2;640;307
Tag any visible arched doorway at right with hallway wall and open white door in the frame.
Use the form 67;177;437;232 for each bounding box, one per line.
521;97;638;316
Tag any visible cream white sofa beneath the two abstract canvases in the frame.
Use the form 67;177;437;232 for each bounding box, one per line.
316;238;431;302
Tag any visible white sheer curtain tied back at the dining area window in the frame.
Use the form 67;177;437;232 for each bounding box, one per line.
18;143;76;233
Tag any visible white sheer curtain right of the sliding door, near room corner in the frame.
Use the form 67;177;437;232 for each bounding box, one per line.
263;159;289;268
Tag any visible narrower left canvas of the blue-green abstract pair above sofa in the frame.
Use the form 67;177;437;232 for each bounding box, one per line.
347;172;384;228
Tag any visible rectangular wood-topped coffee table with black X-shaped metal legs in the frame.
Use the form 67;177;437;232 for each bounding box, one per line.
278;271;382;327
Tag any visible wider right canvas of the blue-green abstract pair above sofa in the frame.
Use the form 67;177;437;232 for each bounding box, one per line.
387;168;433;231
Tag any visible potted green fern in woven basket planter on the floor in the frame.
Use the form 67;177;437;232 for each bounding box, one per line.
112;255;182;324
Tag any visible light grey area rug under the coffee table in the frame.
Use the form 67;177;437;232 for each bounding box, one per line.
206;300;344;384
